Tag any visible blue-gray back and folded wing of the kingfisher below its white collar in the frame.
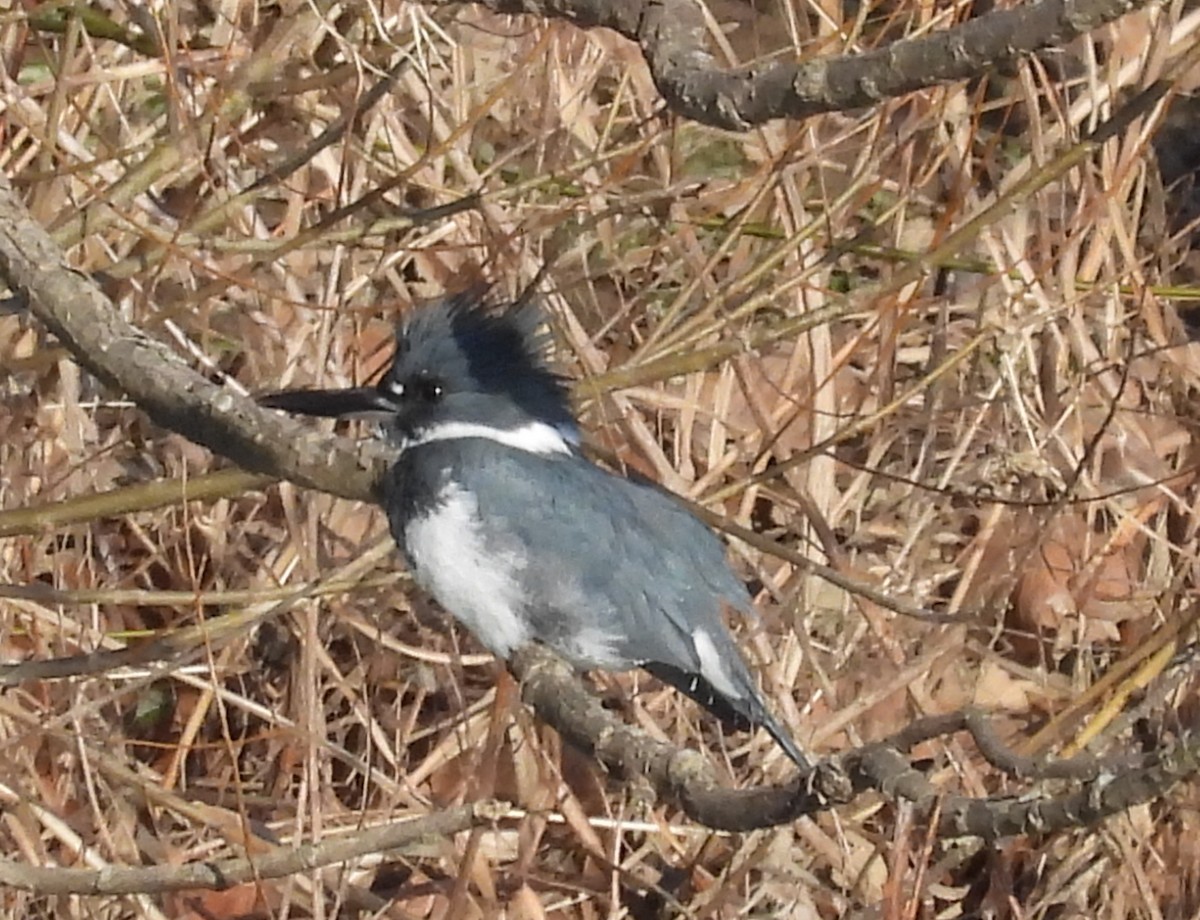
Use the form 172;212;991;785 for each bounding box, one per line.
388;438;750;672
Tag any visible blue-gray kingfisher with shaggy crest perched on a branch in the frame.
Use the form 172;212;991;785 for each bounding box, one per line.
259;289;809;769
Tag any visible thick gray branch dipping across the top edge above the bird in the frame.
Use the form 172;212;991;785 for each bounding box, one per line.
468;0;1146;131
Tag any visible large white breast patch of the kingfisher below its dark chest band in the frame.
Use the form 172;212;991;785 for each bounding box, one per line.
404;484;530;659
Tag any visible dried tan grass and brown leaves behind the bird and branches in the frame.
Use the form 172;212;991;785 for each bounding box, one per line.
0;0;1200;918
